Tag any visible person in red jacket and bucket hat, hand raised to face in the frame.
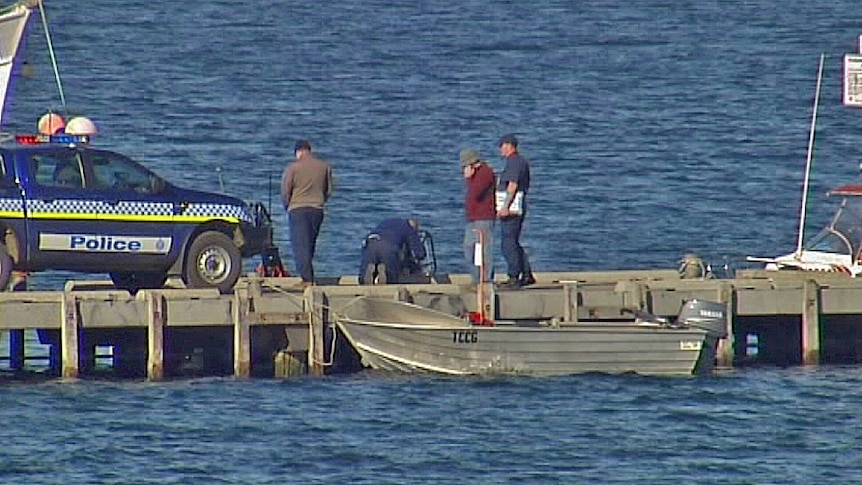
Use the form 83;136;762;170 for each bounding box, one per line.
460;150;497;285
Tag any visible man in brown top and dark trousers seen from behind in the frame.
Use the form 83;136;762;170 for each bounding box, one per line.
281;140;332;285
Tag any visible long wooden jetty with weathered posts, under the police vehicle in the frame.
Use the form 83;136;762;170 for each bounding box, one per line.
5;269;862;380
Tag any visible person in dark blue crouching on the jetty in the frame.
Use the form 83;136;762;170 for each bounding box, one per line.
359;219;426;285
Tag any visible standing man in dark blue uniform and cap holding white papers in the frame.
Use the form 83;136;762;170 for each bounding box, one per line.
497;134;536;288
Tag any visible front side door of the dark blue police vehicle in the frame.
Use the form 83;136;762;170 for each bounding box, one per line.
81;148;180;273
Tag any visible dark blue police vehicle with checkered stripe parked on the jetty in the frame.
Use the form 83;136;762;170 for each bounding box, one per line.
0;134;273;292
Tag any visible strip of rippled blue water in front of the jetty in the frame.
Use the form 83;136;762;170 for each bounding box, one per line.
5;369;862;484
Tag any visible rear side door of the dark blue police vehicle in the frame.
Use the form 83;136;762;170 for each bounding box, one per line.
17;146;112;271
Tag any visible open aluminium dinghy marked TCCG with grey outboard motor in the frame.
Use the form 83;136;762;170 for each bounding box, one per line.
334;297;727;375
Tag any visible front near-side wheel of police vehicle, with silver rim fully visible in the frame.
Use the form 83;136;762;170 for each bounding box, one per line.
183;231;242;293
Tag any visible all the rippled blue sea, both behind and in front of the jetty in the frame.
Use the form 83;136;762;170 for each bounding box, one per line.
5;0;862;484
